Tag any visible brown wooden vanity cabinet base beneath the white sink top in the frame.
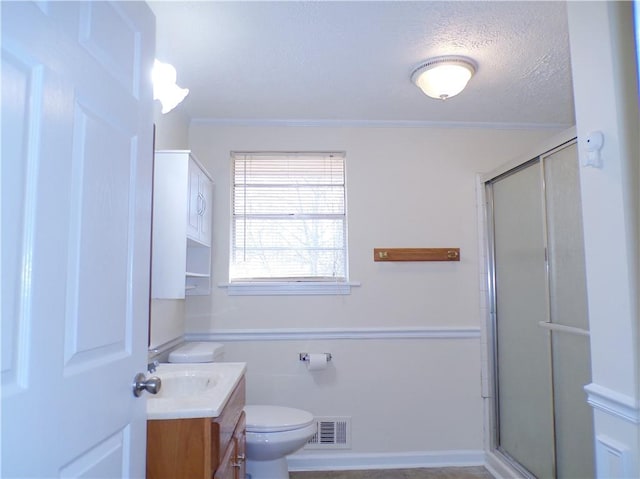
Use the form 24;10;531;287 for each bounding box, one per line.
147;378;246;479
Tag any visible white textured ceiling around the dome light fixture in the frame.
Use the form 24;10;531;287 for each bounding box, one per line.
149;1;574;126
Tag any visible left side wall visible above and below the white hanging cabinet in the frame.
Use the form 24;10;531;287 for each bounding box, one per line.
149;101;189;348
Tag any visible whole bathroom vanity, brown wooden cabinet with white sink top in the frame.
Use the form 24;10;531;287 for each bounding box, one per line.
147;363;246;479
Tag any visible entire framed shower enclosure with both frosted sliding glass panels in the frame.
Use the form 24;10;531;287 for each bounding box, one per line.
484;133;594;479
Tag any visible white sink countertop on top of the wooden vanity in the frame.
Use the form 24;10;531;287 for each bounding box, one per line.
147;363;247;419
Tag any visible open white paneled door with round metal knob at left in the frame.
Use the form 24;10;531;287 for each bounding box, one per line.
0;1;155;478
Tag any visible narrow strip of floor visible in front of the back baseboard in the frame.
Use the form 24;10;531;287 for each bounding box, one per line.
289;466;493;479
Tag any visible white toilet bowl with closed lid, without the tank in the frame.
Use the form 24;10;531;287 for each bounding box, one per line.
244;405;316;479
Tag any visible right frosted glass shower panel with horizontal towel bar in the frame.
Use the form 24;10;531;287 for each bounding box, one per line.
542;143;595;478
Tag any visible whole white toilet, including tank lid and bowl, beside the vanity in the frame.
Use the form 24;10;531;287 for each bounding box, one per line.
169;342;317;479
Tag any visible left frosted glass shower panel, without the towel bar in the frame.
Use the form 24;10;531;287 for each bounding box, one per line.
490;161;555;478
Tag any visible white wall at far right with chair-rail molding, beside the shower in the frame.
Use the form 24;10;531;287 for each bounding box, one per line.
568;2;640;477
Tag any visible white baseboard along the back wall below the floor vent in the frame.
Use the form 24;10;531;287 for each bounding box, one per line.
287;450;485;471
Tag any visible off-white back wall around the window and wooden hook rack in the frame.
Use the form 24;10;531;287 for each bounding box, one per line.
186;123;556;463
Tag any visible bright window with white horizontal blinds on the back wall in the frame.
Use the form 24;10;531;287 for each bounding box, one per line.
229;152;347;292
